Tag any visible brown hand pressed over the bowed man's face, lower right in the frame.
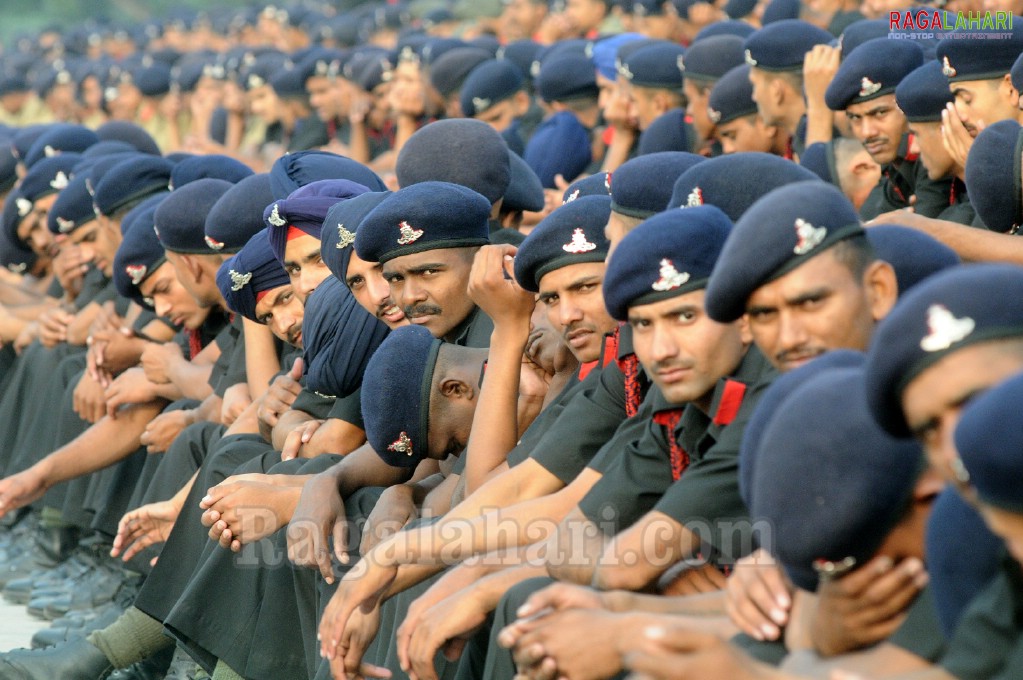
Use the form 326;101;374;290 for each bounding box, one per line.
807;556;928;656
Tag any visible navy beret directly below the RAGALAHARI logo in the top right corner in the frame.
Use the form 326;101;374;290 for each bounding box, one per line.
936;16;1023;83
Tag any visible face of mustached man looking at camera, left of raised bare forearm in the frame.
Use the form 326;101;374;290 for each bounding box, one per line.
384;247;476;337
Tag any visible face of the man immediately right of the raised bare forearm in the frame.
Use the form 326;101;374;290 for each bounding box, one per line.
539;262;615;363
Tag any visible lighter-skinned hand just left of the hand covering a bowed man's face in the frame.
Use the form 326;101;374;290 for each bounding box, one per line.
724;549;792;642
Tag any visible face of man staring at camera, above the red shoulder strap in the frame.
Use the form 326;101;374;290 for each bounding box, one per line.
629;290;745;404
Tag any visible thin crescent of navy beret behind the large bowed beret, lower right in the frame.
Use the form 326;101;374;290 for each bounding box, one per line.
739;350;866;507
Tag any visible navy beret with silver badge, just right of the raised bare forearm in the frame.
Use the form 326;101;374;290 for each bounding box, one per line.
515;196;611;292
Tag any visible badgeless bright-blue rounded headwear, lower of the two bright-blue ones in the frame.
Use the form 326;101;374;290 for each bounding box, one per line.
525;111;593;189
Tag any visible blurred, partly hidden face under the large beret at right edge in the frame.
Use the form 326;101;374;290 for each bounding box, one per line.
902;341;1023;482
